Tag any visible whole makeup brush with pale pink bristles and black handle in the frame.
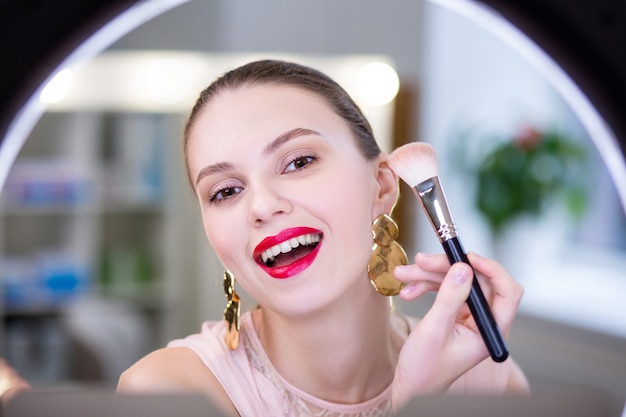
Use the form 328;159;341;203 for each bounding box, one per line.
389;142;509;362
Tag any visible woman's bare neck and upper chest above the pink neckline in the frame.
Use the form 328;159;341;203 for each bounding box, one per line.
253;289;408;403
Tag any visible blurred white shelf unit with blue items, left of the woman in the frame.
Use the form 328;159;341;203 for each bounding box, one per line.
0;111;185;353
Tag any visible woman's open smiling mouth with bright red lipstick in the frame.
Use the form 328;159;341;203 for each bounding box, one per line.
254;227;322;279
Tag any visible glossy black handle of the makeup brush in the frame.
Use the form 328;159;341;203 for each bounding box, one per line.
441;237;509;362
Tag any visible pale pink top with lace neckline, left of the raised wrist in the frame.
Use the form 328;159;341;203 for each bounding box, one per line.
167;312;391;417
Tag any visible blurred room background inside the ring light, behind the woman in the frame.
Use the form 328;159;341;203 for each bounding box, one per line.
0;0;626;404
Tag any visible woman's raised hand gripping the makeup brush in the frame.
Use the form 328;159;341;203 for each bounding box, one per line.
392;253;523;410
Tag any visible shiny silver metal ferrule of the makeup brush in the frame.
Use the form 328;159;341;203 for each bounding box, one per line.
415;177;458;242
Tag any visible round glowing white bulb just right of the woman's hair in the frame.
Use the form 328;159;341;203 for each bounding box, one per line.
356;62;400;106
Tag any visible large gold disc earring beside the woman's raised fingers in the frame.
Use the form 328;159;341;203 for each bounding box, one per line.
367;214;408;296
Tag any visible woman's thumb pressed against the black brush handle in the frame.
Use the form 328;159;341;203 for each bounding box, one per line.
428;262;474;327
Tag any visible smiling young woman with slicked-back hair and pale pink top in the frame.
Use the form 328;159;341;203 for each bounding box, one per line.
118;60;528;416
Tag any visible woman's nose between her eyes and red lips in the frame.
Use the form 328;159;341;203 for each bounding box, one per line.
246;181;292;226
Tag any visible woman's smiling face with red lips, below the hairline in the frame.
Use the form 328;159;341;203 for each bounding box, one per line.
188;85;389;314
